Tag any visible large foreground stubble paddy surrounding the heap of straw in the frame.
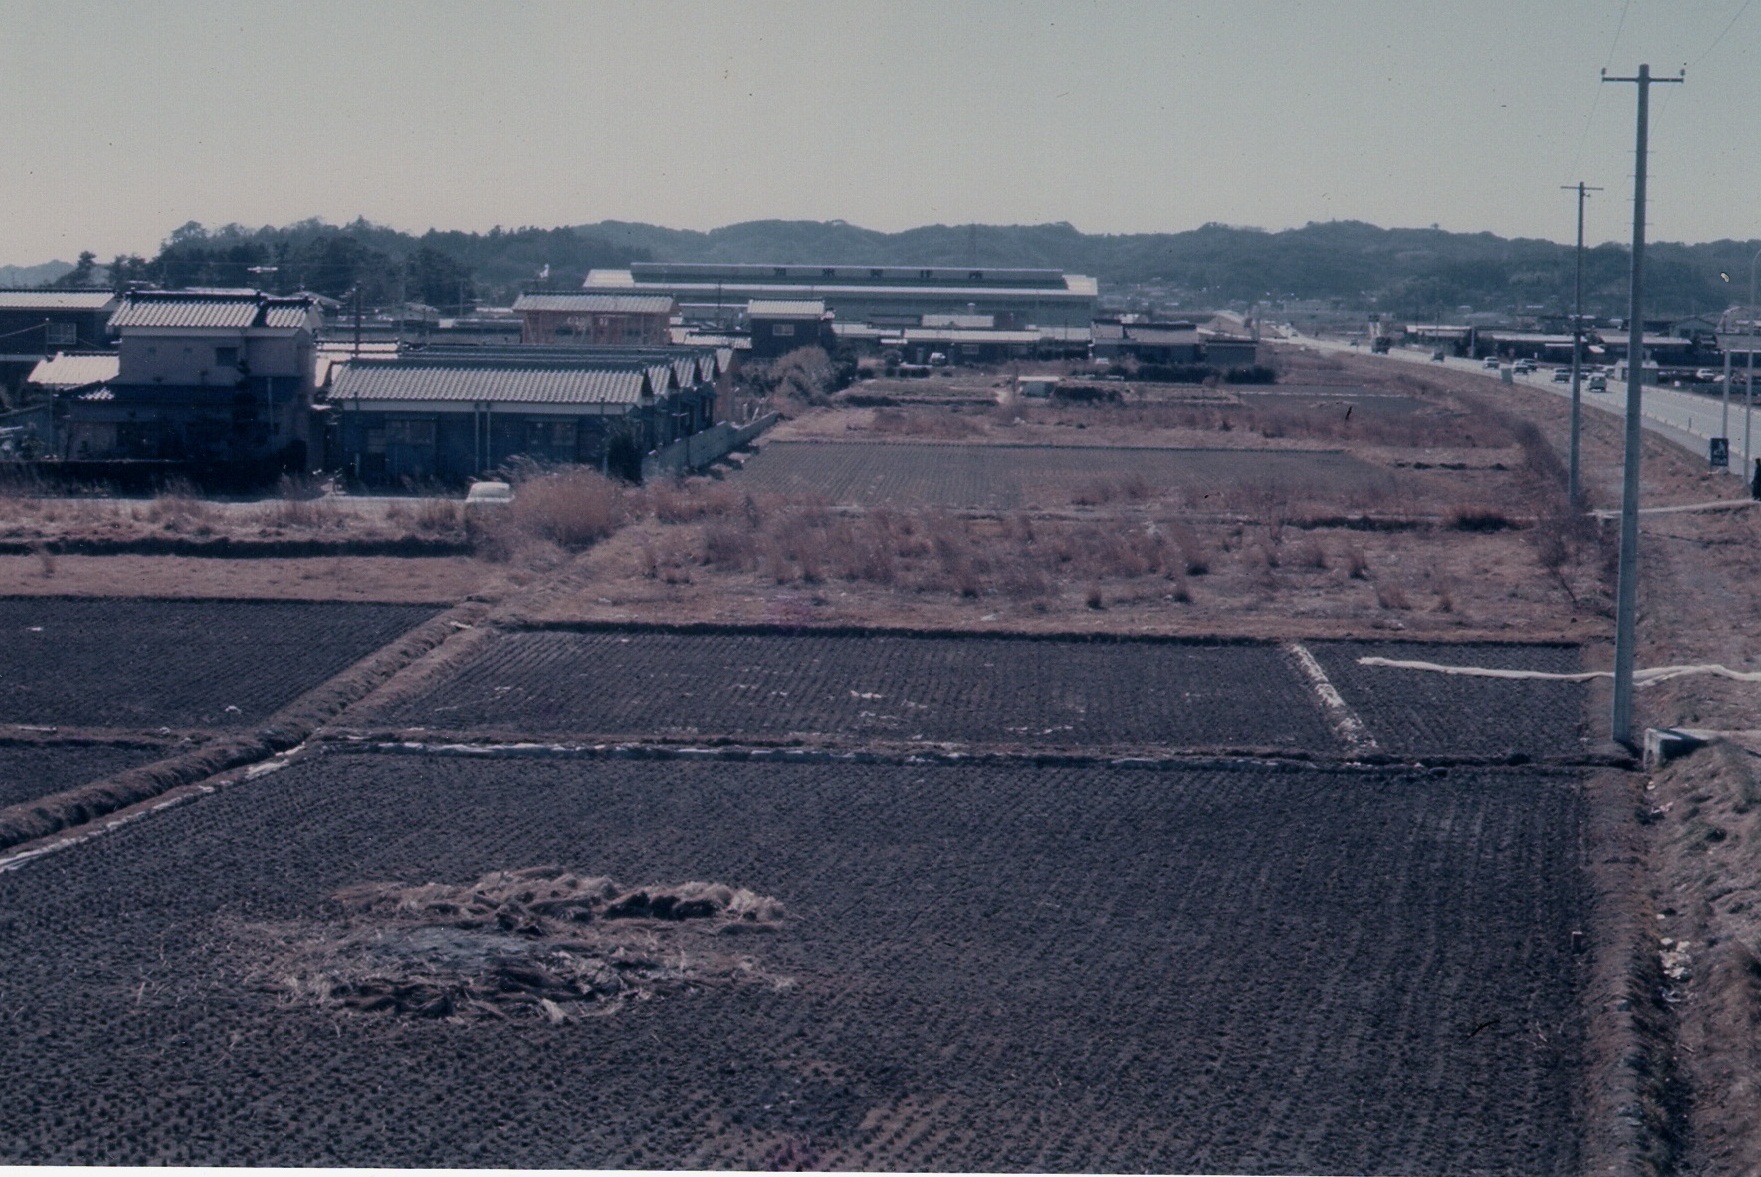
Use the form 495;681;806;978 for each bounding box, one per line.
0;754;1585;1173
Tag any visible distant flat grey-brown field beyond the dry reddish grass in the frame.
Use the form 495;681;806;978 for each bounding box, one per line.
738;442;1389;509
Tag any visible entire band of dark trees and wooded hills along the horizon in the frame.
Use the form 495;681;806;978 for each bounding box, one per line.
27;218;1761;321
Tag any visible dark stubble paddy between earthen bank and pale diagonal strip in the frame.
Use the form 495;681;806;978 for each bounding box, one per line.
368;633;1335;751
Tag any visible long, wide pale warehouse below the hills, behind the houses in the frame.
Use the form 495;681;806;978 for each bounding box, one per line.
583;263;1099;329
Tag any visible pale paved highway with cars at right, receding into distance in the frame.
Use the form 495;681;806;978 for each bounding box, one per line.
1286;329;1761;477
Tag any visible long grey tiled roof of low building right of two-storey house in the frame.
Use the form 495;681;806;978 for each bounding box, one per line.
331;359;653;405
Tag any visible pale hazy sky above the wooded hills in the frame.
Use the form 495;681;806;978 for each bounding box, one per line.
0;0;1761;264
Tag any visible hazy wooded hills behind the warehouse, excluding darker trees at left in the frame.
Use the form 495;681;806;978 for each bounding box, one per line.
579;220;1761;317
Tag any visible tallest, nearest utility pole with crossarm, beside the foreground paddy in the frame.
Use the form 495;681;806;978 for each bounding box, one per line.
1603;65;1687;747
